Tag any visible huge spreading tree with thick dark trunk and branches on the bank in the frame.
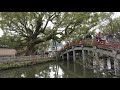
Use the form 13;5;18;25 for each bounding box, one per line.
0;12;112;55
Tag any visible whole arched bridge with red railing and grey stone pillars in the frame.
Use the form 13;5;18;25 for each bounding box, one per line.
57;39;120;74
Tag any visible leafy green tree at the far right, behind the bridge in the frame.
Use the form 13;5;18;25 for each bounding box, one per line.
100;13;120;41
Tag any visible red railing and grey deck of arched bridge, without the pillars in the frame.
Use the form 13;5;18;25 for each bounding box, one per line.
59;39;120;61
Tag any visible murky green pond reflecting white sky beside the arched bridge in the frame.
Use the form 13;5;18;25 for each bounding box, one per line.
0;61;117;78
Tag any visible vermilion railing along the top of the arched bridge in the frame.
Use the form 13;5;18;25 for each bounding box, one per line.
60;39;120;51
